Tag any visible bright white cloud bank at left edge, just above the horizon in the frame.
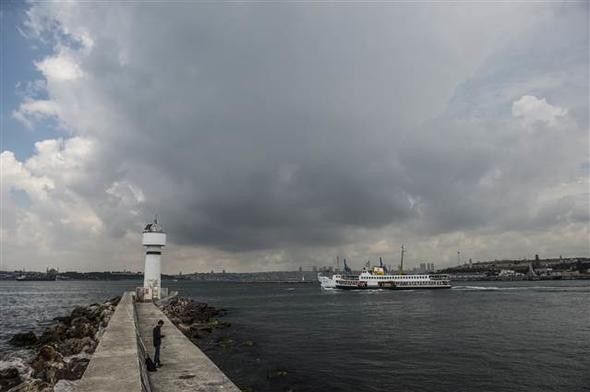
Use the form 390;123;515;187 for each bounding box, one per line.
0;137;113;269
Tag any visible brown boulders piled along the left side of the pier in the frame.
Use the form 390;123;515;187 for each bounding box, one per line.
0;297;121;392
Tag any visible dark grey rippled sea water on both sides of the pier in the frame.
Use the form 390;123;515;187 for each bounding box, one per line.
0;281;590;391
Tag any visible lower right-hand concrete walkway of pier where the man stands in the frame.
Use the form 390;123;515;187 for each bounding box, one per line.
136;303;240;392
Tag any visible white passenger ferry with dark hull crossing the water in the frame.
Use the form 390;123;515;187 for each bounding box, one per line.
318;267;451;290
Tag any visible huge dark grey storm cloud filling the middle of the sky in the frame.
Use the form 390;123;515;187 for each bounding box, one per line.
54;1;583;250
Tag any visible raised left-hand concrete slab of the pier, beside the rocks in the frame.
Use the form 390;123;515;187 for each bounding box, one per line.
75;292;141;392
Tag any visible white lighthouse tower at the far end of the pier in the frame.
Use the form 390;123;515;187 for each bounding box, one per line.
142;216;166;299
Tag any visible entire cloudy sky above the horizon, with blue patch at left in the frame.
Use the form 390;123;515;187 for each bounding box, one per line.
0;1;590;273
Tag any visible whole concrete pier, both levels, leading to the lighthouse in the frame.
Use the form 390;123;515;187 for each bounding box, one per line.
75;292;239;392
